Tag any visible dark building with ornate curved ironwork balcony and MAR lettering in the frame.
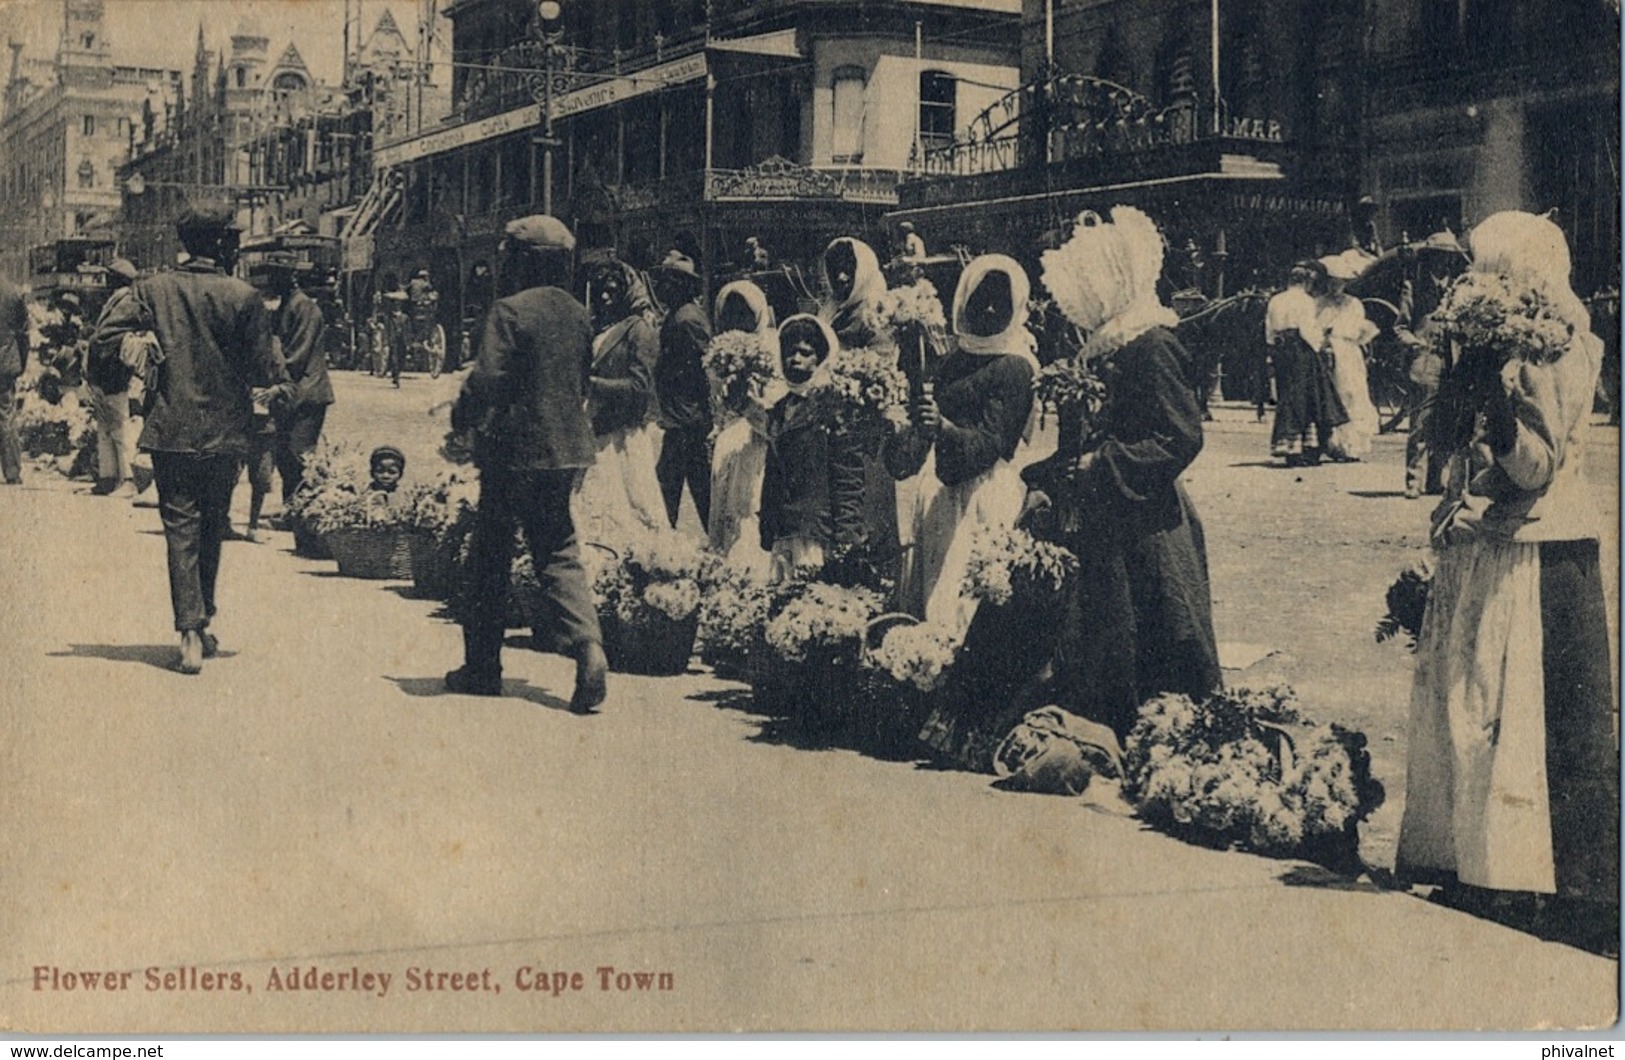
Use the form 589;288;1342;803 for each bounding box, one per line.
894;0;1362;294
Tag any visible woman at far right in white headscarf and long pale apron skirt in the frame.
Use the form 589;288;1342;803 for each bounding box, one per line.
1398;211;1620;946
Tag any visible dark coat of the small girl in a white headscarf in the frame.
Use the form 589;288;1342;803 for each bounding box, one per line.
761;395;869;551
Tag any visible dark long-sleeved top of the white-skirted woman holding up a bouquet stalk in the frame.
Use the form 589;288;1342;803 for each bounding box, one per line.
884;353;1032;486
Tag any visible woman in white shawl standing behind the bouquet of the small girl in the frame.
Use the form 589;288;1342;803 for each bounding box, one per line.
819;236;899;566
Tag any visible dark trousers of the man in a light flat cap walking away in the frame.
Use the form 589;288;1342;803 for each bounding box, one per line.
460;468;603;675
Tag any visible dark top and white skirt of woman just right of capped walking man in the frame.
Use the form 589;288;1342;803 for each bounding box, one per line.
572;314;668;543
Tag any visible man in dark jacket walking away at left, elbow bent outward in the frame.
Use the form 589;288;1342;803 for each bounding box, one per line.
96;208;294;673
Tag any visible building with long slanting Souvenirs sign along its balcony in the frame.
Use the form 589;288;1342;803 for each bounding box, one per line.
353;0;1019;318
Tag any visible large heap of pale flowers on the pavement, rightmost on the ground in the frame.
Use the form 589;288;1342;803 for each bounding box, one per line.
1123;688;1383;865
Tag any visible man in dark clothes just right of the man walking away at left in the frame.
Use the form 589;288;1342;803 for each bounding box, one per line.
267;255;333;509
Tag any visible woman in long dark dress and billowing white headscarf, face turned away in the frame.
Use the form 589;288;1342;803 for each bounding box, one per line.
1025;206;1220;738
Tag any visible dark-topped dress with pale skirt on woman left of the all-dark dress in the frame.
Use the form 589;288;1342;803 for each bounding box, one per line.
884;351;1034;641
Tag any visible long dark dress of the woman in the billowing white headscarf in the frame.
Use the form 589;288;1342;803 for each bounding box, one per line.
1025;327;1222;738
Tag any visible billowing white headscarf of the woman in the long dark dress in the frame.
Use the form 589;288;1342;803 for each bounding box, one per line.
1040;206;1180;356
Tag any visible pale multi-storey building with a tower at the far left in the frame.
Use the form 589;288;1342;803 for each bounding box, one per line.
0;0;182;276
